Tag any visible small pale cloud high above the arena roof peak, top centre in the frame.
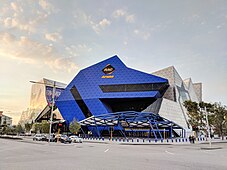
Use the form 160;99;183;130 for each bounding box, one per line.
112;9;135;23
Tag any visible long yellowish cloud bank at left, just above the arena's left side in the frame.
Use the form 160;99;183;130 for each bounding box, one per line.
0;32;77;72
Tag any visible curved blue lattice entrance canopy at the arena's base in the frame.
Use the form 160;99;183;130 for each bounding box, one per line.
80;111;184;139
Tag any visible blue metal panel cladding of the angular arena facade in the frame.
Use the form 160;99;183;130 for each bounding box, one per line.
56;56;168;127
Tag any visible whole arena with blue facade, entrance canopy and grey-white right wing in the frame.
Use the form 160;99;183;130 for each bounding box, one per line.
52;56;202;139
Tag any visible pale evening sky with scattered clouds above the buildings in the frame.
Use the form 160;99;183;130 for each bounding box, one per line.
0;0;227;124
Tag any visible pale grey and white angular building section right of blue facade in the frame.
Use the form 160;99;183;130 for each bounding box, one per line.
146;66;202;133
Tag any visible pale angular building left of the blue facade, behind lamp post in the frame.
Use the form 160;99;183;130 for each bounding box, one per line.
19;78;66;124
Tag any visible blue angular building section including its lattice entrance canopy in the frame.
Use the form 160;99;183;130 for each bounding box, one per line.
56;56;184;138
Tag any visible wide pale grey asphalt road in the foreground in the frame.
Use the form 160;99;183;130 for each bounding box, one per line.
0;139;227;170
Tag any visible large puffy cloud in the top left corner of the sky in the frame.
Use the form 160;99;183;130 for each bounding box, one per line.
0;0;54;33
